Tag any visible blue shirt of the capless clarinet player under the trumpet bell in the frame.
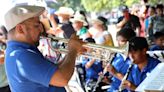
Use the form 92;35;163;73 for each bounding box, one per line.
108;54;131;92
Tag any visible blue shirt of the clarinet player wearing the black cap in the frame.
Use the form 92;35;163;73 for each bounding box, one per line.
128;57;160;91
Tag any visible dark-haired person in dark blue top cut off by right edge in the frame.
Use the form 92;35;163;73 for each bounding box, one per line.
150;32;164;51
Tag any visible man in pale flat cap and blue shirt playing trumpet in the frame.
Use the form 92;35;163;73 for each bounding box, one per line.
4;5;84;92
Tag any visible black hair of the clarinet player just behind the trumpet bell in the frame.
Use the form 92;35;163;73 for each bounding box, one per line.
117;28;136;40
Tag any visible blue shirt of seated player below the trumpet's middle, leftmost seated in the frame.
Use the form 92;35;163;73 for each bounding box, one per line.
82;58;103;81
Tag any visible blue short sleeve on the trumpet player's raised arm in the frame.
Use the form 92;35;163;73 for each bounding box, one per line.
16;51;57;87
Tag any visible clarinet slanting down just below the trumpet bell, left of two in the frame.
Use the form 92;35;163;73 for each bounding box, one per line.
92;53;116;92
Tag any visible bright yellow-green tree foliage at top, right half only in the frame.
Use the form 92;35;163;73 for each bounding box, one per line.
81;0;164;12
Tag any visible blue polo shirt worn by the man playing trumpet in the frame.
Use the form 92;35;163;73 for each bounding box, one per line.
5;41;65;92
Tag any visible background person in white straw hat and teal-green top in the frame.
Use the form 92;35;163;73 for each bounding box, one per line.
70;14;89;40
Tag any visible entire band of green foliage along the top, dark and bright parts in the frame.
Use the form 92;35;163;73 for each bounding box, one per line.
53;0;164;12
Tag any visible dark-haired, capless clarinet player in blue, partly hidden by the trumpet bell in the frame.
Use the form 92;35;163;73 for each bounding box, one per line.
108;28;136;92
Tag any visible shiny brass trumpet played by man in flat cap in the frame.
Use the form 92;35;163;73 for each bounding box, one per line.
41;36;129;61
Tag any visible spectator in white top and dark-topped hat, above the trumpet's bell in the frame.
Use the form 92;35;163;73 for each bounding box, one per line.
88;16;113;46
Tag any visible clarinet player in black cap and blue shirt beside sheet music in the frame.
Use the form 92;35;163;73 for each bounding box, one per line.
121;37;160;91
